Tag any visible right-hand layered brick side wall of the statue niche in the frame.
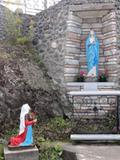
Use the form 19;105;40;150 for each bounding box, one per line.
102;11;118;81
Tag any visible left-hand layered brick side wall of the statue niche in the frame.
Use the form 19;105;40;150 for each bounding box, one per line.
64;12;82;82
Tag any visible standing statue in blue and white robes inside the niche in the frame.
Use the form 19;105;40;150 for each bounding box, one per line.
86;29;99;77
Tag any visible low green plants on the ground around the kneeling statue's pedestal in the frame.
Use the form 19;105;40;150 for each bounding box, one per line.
0;117;71;160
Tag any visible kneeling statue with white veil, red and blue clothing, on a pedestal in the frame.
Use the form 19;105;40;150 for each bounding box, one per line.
8;104;37;147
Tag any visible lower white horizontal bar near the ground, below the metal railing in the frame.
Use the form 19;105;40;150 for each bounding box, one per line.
70;134;120;141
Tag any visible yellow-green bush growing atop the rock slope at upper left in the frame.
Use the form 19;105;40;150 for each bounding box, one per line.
5;10;34;45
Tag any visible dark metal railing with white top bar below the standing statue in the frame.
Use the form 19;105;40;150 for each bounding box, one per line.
68;91;120;133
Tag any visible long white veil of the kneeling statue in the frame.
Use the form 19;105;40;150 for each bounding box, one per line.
19;104;30;134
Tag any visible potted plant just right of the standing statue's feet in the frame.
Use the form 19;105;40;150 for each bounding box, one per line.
98;69;108;82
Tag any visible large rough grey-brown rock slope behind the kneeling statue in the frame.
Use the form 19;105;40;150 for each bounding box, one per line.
0;42;70;133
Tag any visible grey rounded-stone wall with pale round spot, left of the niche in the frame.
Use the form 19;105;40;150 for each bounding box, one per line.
36;0;68;82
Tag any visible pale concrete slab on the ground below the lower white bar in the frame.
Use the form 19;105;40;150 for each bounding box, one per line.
63;144;120;160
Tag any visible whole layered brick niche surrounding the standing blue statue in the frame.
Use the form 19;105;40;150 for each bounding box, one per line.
64;3;118;82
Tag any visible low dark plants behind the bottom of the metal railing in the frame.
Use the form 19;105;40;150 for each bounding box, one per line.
73;111;116;134
